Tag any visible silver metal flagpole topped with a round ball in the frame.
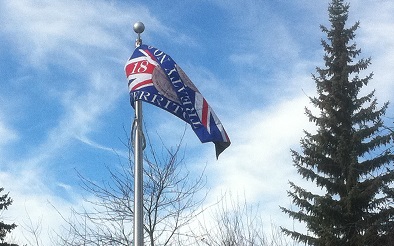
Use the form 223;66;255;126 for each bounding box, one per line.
133;22;145;246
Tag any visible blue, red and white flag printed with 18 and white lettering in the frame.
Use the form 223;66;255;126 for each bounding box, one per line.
125;44;230;157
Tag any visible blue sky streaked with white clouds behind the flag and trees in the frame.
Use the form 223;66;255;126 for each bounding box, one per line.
0;0;394;245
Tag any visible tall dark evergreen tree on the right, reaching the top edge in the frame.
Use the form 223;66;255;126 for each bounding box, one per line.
281;0;394;246
